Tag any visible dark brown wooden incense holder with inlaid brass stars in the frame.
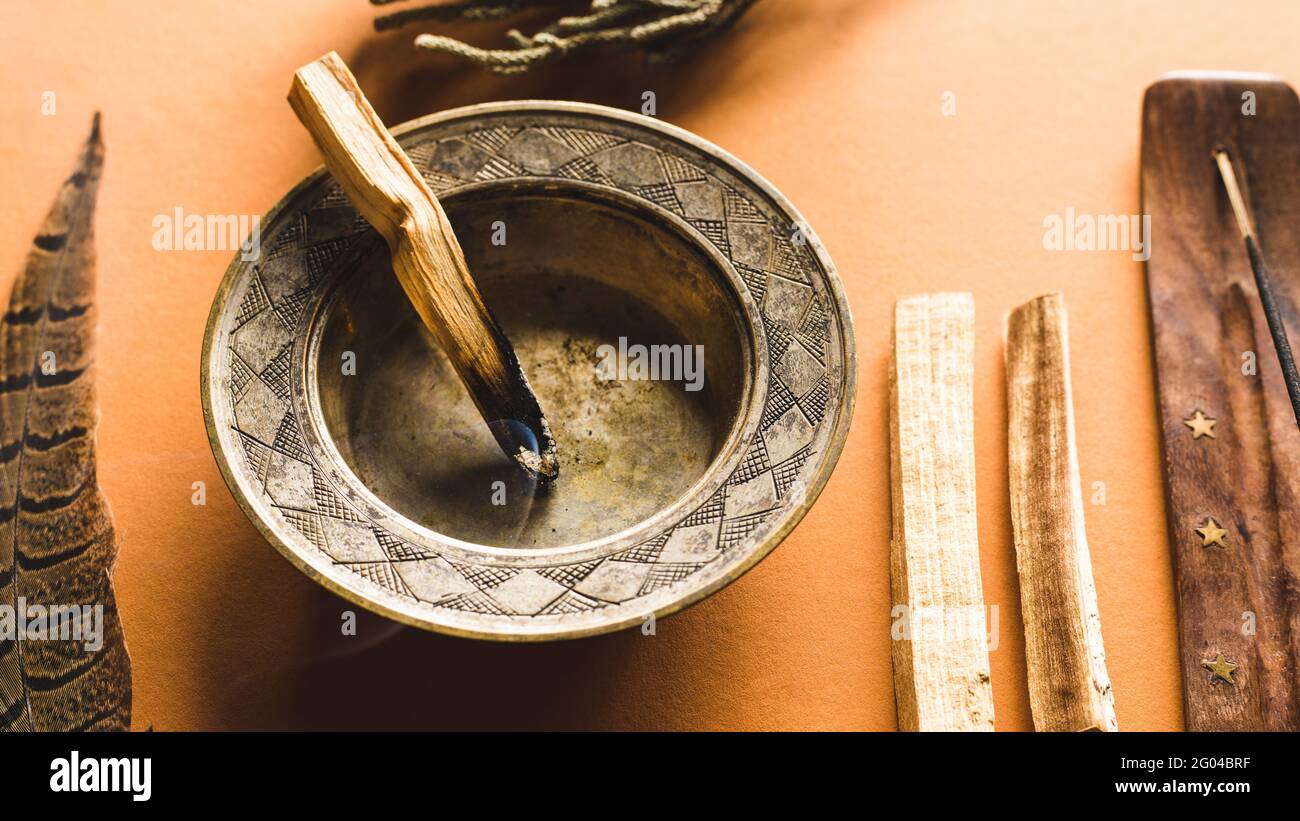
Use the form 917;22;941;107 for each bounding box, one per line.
1141;75;1300;730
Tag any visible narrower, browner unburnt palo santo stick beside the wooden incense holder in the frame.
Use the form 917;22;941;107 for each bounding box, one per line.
1006;294;1118;731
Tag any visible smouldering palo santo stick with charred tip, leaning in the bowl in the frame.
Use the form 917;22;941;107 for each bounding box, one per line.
289;52;559;482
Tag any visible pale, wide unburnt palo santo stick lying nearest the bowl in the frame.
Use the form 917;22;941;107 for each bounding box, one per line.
889;294;993;730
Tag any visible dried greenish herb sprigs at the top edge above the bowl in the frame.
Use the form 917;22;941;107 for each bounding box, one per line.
371;0;755;74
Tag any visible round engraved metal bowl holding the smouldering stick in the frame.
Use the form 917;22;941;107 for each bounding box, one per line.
202;101;855;640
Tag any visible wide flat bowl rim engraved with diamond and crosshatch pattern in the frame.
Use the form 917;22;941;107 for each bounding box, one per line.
203;103;855;639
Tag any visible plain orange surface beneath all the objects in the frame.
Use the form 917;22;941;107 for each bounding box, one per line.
0;0;1300;730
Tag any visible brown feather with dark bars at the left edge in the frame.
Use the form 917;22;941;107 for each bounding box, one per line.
0;113;131;730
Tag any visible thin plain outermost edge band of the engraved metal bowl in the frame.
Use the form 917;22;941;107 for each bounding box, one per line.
199;100;857;642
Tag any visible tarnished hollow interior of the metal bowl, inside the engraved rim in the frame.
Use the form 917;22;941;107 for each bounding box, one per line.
308;182;754;548
